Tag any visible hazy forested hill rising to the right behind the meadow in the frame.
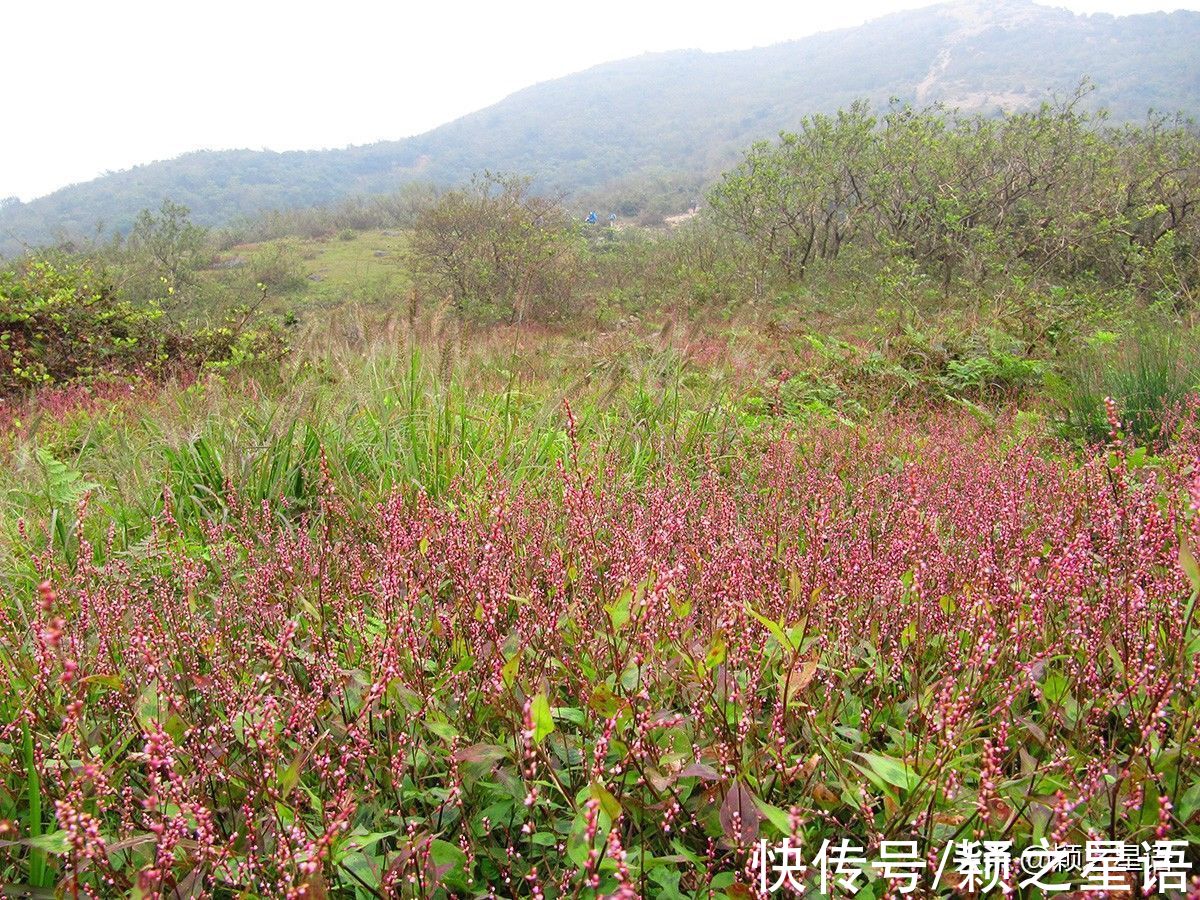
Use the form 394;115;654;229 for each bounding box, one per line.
0;0;1200;256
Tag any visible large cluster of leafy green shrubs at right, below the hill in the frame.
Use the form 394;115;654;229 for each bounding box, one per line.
709;90;1200;299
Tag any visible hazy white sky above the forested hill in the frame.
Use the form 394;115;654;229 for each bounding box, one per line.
0;0;1200;200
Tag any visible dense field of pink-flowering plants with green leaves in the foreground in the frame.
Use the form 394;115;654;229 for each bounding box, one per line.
0;412;1200;898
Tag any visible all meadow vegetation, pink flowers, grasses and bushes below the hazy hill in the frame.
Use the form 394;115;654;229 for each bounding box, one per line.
0;95;1200;899
